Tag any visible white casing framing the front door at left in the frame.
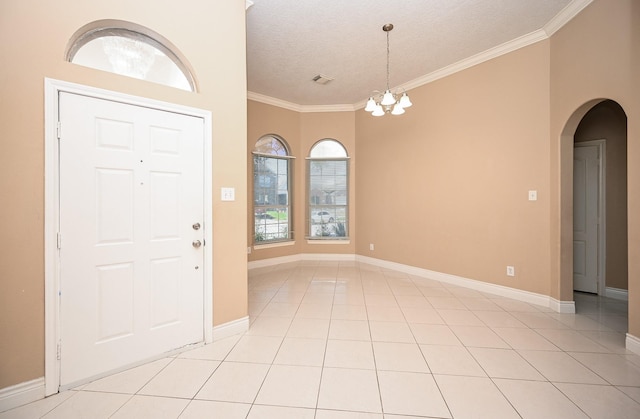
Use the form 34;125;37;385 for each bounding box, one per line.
44;78;213;396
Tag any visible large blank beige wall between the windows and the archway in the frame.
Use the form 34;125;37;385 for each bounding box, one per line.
356;41;550;295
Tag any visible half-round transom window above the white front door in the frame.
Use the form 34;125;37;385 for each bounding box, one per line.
66;20;196;91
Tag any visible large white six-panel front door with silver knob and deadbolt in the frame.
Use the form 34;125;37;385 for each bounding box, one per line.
59;93;204;387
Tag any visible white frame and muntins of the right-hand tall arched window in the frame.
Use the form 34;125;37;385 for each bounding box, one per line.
306;138;351;242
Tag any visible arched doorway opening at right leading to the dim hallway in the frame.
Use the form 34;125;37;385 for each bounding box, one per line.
561;99;628;323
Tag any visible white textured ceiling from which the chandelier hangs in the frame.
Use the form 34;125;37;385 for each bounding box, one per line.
247;0;591;109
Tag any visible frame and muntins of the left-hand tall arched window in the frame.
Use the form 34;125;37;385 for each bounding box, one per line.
251;134;295;246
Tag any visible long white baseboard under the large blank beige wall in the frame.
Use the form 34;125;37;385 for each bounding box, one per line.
356;255;575;313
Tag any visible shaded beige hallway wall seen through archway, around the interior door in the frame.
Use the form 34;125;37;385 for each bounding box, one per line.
574;100;628;289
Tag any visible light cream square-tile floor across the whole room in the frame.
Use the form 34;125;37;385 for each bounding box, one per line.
0;262;640;419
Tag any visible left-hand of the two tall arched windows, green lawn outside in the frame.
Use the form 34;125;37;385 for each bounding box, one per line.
253;135;293;244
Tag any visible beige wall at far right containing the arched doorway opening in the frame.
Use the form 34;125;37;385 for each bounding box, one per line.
550;0;640;337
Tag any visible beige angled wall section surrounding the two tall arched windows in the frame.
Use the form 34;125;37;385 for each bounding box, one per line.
247;100;357;261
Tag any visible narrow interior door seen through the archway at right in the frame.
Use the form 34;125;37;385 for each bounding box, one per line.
573;145;600;293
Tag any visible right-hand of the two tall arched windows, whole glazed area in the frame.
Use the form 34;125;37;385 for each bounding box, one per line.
307;139;349;239
